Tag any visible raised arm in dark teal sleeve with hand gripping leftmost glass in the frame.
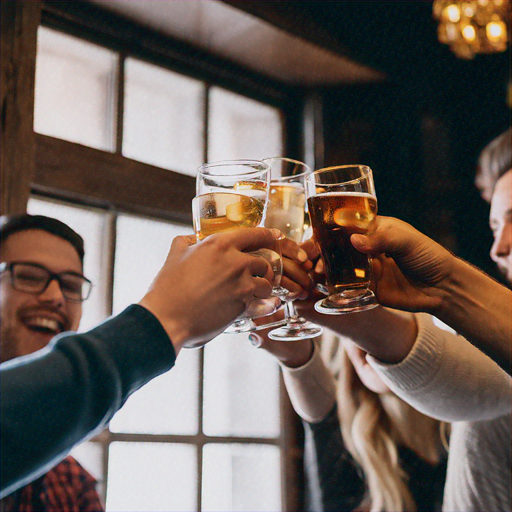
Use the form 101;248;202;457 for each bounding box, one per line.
0;228;280;496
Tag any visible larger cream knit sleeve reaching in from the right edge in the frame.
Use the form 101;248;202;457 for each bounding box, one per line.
367;314;512;422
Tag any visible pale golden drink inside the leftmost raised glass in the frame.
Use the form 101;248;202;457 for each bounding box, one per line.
192;192;265;240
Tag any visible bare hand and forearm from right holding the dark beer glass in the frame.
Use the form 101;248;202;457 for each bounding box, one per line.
352;217;512;374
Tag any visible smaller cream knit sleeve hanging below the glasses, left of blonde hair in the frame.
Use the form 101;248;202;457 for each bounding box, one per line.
281;343;336;423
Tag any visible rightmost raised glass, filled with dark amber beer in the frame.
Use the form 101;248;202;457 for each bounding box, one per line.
306;165;377;315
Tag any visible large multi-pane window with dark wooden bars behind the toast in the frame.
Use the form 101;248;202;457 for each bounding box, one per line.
28;10;296;511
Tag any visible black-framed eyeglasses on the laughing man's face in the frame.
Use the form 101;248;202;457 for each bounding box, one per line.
0;262;92;302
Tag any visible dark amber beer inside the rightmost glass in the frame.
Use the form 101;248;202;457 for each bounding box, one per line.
308;192;377;295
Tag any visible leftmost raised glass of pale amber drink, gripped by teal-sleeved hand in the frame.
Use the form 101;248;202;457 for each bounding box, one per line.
192;160;282;333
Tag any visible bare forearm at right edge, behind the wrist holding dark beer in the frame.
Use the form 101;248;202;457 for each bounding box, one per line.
435;259;512;375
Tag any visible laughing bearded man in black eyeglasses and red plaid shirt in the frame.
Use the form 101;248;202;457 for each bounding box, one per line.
0;215;103;512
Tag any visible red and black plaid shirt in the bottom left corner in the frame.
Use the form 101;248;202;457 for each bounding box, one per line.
0;457;104;512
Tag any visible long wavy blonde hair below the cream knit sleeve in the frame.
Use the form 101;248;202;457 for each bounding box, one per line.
322;337;447;512
